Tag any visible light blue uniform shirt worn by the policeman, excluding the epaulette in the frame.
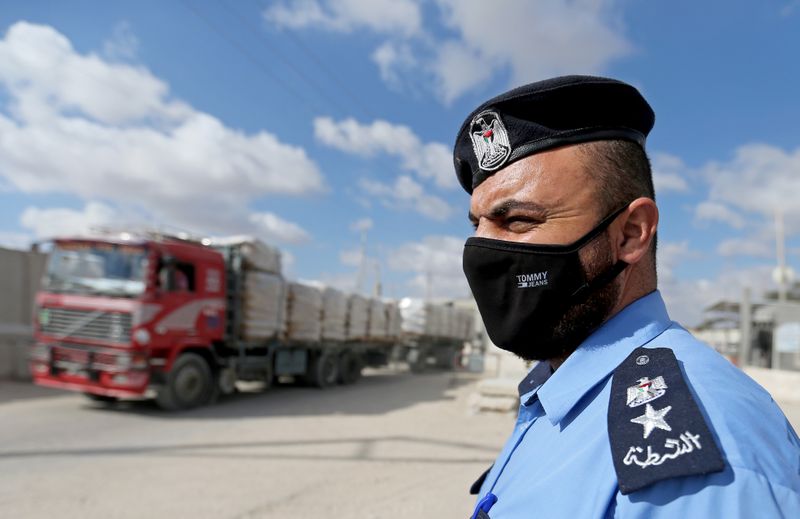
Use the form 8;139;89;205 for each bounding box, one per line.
479;291;800;519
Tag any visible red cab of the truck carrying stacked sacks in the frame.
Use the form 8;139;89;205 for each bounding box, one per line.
31;233;226;408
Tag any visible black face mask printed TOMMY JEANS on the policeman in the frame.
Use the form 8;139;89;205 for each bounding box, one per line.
463;204;628;358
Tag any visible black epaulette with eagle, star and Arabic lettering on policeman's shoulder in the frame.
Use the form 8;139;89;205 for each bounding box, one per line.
608;348;725;494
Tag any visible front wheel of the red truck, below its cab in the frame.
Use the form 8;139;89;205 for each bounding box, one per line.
156;353;216;411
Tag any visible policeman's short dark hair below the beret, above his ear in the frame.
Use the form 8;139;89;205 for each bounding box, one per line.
579;140;657;271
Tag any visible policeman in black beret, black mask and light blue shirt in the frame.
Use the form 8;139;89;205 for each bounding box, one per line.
454;76;800;519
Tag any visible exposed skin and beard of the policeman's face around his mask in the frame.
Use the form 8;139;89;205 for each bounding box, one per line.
470;146;620;360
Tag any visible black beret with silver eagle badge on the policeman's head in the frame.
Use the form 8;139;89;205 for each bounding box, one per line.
453;76;655;193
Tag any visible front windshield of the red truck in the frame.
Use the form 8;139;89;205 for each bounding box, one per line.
42;243;147;297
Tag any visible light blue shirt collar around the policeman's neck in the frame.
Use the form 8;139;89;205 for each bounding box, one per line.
536;290;672;425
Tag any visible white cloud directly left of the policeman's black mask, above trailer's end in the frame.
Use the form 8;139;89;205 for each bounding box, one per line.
388;236;470;298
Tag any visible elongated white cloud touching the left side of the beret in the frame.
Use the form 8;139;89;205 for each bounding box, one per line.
314;117;457;188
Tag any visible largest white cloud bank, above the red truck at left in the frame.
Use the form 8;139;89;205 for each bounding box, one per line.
0;22;324;248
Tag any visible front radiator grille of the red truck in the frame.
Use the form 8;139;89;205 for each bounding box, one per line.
39;308;131;343
